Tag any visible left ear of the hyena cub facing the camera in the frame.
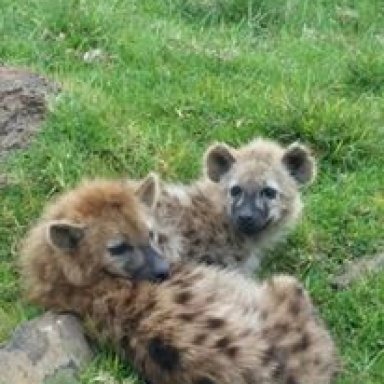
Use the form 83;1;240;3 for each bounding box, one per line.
204;144;236;183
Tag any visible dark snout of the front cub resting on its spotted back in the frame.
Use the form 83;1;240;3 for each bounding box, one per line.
138;246;170;282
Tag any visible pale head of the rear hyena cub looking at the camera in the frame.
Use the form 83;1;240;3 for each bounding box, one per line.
205;139;316;238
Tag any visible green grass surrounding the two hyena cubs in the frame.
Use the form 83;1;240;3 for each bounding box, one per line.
0;0;384;384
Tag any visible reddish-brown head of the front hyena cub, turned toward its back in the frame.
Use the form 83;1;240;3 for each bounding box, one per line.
24;178;169;285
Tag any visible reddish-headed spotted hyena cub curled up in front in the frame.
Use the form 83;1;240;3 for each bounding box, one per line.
21;181;335;384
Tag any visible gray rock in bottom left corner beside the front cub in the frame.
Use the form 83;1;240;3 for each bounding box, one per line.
0;312;93;384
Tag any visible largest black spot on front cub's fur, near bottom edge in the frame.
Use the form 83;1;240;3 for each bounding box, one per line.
148;337;180;371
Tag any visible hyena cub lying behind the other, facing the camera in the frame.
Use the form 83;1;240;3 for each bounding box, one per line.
152;139;316;274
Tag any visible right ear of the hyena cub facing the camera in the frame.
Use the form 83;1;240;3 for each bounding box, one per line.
283;143;316;185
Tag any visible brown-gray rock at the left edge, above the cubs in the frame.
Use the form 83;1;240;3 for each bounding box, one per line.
0;67;59;158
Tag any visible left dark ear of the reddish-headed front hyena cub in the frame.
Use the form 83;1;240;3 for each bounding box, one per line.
47;221;85;252
